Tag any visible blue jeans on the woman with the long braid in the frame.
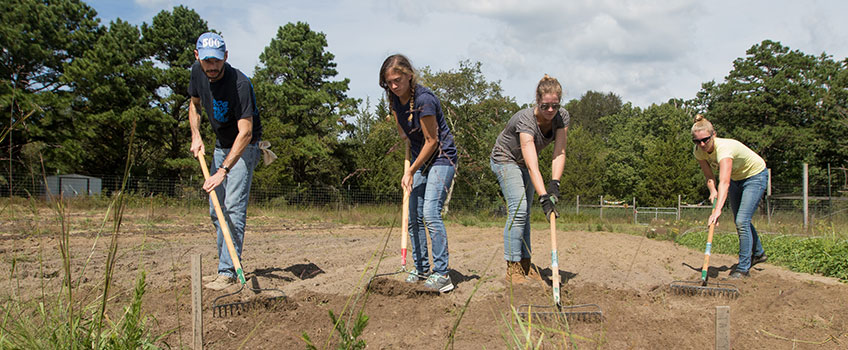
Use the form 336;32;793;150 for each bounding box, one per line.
409;165;456;275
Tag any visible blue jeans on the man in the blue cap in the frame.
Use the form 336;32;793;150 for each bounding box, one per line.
209;143;260;277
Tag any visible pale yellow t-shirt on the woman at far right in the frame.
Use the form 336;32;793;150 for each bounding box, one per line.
692;137;766;181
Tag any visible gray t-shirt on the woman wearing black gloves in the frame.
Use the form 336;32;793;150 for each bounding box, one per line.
491;107;571;168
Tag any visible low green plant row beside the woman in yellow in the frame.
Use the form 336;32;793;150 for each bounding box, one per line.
675;231;848;283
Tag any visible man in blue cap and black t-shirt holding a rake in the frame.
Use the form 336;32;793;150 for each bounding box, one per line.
188;32;262;290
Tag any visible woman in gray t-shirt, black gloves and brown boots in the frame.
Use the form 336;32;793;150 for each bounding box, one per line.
489;74;571;284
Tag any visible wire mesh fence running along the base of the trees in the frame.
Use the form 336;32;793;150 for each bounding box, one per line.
0;170;848;230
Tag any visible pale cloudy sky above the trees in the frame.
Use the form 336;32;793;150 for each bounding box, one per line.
86;0;848;107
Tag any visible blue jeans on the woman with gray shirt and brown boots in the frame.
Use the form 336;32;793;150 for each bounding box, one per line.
489;159;536;261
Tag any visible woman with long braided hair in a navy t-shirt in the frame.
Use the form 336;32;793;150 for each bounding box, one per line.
380;55;457;292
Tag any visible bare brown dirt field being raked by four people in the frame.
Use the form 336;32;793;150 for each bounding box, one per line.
0;209;848;349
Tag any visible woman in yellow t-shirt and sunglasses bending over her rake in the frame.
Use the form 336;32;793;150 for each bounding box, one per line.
692;114;768;279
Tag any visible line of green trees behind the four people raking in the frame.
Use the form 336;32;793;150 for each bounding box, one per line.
0;0;848;207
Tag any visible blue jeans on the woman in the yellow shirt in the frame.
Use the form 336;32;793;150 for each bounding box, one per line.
727;170;768;272
